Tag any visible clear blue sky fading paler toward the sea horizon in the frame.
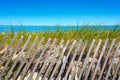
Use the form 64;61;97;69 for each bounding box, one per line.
0;0;120;25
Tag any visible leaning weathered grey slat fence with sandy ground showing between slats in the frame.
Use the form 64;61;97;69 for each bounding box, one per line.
0;33;120;80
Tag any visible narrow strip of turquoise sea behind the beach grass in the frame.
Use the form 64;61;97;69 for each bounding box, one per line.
0;25;120;32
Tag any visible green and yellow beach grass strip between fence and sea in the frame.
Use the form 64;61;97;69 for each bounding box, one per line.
0;26;120;52
